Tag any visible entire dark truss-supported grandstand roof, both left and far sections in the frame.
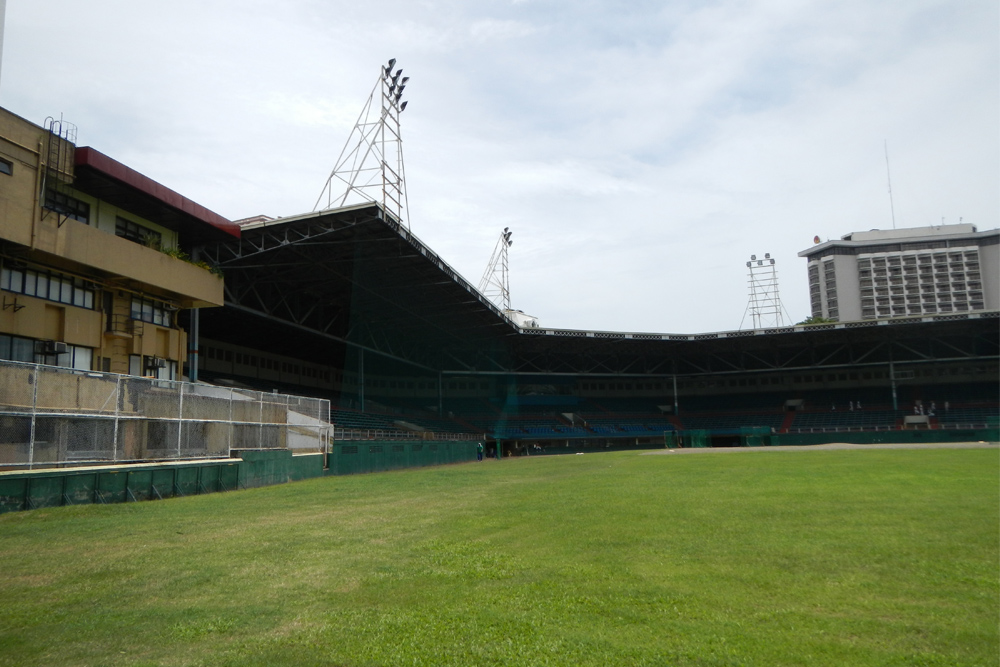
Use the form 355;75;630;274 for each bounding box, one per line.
204;204;1000;376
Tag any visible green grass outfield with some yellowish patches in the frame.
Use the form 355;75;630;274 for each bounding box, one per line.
0;449;1000;667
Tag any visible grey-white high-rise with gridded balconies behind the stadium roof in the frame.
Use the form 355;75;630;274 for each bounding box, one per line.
799;224;1000;322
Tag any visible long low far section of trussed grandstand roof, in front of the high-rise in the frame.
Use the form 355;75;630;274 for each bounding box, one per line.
512;312;1000;377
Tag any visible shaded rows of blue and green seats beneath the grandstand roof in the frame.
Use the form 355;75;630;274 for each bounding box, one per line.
332;385;1000;439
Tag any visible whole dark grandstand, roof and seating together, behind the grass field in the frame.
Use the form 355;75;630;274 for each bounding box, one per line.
187;204;1000;452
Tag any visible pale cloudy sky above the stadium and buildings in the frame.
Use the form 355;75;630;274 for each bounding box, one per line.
0;0;1000;333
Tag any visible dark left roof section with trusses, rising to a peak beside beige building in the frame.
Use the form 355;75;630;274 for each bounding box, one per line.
202;204;516;372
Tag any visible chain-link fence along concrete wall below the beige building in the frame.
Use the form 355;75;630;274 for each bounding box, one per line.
0;361;331;468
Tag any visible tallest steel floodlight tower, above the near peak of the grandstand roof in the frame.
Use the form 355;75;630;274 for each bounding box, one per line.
313;58;410;228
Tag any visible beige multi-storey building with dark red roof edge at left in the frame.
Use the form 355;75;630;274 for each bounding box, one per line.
0;108;239;379
